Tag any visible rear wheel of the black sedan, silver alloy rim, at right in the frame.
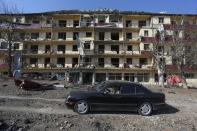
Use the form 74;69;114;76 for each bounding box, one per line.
138;102;152;116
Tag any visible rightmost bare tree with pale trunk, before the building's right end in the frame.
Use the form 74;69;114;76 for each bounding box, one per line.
170;16;197;88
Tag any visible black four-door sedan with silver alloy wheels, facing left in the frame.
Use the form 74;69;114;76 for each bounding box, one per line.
66;81;165;116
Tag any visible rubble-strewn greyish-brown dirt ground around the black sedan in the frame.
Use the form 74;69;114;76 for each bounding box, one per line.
0;80;197;131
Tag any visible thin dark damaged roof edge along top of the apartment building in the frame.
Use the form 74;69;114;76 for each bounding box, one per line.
0;10;197;16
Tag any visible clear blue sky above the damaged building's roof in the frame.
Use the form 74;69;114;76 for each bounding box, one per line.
0;0;197;14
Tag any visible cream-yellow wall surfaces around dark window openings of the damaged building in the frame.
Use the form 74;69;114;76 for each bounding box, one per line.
0;14;197;83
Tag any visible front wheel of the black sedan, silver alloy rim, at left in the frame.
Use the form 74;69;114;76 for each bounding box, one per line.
74;100;89;114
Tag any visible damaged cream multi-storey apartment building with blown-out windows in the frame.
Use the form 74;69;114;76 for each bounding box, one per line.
1;10;197;84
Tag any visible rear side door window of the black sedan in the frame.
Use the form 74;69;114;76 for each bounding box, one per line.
120;84;135;95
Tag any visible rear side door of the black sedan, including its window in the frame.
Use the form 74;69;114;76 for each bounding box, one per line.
120;83;138;111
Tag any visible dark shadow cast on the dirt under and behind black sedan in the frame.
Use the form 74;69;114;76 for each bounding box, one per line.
90;104;179;116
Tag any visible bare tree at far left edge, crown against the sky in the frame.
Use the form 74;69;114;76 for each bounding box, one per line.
0;1;20;77
